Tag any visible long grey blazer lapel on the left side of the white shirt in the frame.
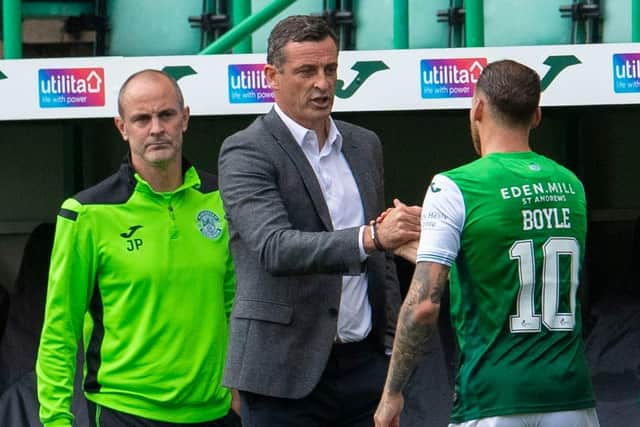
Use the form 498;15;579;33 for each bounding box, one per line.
264;108;333;231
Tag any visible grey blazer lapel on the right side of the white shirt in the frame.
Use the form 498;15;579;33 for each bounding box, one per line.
336;122;377;221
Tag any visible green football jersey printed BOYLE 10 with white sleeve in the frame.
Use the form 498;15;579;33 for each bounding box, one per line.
417;152;595;423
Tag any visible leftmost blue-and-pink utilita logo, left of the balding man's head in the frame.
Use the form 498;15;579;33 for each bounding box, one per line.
38;68;104;108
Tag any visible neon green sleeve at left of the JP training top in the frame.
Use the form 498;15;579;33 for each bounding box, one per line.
36;199;95;427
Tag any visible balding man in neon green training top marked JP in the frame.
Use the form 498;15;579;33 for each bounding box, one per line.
36;70;238;427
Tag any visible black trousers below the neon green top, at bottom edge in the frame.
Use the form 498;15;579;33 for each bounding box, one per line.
87;401;241;427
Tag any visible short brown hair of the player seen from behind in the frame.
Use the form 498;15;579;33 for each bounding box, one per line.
476;59;540;126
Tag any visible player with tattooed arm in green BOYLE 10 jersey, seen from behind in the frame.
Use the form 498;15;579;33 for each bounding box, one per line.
375;60;599;427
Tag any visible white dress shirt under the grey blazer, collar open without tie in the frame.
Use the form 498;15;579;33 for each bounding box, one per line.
274;104;372;342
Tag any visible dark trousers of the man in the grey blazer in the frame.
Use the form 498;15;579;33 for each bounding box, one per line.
240;341;389;427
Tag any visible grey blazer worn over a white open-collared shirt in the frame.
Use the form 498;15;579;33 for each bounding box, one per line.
218;109;400;399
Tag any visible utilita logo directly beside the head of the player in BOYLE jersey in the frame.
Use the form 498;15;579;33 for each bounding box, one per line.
420;58;487;98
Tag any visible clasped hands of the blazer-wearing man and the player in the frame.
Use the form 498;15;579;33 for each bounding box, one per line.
376;199;422;251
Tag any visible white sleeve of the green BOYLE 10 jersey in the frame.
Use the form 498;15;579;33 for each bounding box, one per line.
416;175;465;267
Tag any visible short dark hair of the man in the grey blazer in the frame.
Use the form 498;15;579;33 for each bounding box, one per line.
267;15;338;69
